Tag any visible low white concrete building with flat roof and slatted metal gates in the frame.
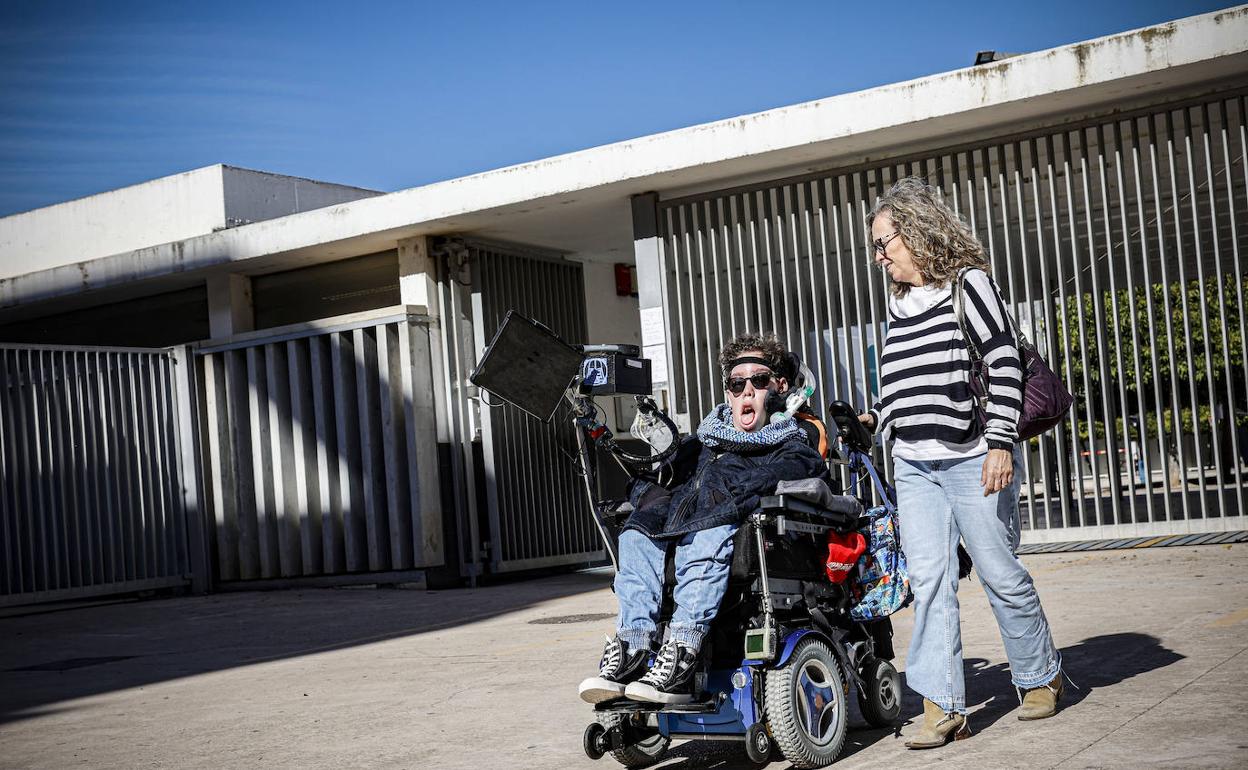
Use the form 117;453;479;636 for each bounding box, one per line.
0;6;1248;606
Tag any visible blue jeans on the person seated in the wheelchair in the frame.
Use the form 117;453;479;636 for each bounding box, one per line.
615;524;738;650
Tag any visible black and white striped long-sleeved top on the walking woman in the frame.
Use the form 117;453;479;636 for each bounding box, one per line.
871;270;1022;461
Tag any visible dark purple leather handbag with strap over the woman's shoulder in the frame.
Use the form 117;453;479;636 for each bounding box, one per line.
952;267;1075;441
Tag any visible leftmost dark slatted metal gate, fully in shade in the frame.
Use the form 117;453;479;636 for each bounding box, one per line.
0;344;207;607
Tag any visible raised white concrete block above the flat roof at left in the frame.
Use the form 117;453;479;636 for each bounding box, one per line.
0;165;381;280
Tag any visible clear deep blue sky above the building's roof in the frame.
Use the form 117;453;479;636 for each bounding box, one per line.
0;0;1227;215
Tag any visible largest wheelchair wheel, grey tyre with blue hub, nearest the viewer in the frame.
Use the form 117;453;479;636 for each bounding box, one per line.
763;638;849;768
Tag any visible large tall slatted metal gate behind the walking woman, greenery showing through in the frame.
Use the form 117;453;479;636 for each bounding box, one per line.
658;92;1248;542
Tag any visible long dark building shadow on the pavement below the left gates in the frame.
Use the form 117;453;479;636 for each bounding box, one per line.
0;570;614;724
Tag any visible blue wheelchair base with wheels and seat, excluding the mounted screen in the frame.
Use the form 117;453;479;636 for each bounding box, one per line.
584;441;901;768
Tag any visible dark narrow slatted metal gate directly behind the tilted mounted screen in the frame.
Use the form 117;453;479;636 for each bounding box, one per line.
441;241;605;573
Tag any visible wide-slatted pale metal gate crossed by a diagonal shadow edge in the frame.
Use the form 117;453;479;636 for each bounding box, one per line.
196;306;443;582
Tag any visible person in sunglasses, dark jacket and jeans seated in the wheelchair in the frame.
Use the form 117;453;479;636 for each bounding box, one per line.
579;334;827;704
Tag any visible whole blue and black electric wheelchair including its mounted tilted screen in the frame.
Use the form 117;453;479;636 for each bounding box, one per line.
469;311;901;768
